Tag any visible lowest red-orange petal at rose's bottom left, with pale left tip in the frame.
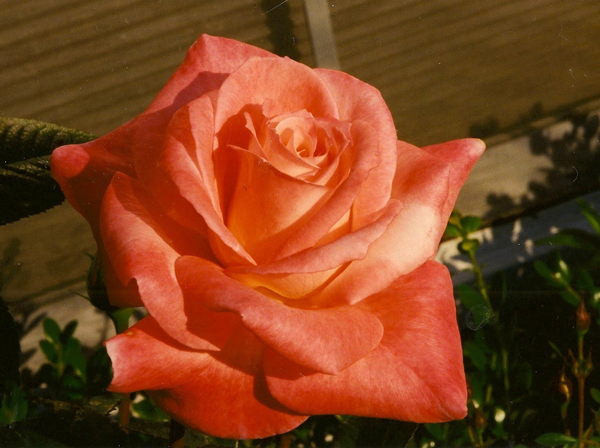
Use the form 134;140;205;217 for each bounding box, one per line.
106;317;306;439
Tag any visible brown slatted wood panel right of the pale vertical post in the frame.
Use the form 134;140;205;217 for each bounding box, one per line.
329;0;600;145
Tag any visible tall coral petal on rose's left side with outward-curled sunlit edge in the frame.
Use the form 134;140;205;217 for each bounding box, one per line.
100;173;231;350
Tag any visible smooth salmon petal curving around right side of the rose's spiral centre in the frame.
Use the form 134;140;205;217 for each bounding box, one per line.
315;69;397;229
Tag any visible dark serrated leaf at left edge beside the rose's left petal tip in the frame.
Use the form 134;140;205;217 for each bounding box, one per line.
0;117;94;225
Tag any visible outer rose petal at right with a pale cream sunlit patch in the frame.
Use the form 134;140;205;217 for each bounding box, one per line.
321;142;450;303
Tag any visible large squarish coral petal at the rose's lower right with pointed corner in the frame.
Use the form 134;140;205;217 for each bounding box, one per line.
265;261;467;422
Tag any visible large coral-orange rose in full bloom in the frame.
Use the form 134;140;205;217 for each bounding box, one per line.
52;36;483;438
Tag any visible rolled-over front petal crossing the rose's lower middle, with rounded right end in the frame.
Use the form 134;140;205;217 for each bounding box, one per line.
176;257;382;373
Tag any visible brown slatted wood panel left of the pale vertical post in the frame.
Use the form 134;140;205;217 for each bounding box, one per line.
0;0;312;135
